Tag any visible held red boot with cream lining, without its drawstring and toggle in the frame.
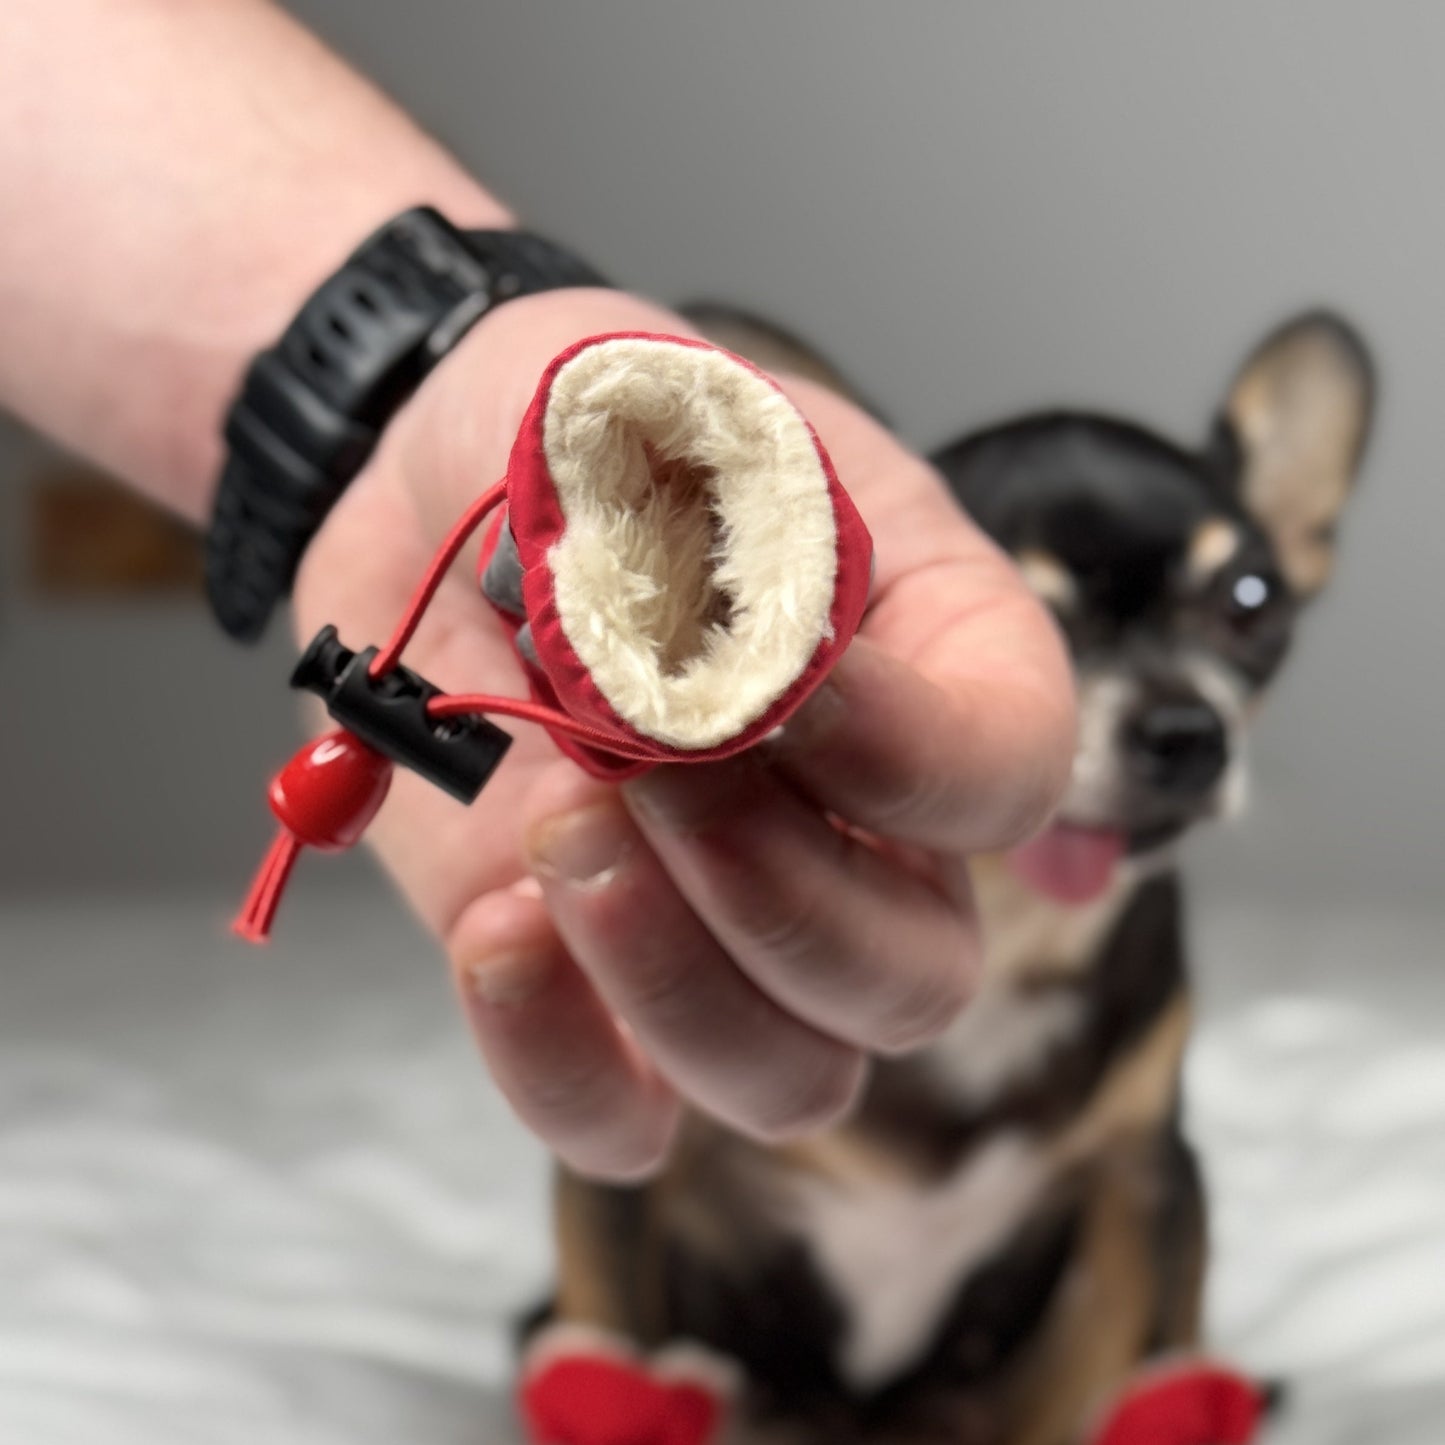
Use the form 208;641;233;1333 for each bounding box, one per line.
481;334;873;777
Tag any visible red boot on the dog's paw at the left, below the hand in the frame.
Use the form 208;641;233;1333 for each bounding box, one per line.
517;1325;740;1445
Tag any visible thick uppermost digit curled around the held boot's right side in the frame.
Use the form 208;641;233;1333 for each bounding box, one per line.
757;379;1074;853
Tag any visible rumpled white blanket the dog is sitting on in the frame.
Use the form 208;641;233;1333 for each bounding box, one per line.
0;897;1445;1445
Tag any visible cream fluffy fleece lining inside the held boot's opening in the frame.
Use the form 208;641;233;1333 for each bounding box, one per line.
542;338;837;749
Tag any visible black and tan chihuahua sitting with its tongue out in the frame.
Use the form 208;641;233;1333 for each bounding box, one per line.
536;311;1374;1445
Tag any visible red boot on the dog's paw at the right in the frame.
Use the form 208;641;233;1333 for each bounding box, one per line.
1087;1360;1273;1445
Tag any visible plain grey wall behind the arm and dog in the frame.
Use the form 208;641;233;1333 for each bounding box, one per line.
0;0;1445;907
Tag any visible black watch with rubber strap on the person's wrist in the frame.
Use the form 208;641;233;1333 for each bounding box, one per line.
205;207;607;642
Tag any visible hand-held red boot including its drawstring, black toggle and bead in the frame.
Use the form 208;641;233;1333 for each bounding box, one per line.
236;332;873;942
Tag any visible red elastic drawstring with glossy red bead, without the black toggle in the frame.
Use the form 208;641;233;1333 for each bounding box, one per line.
231;478;647;944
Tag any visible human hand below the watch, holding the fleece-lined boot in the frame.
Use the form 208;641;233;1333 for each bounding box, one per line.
295;292;1072;1178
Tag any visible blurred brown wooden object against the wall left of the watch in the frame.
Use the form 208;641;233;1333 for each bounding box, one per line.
22;462;201;600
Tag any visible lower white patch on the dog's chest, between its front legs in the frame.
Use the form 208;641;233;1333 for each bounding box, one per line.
798;1133;1049;1389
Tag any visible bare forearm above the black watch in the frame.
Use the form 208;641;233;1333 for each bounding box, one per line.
0;0;510;519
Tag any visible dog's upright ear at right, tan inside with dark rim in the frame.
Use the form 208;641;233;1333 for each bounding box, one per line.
1218;312;1374;597
